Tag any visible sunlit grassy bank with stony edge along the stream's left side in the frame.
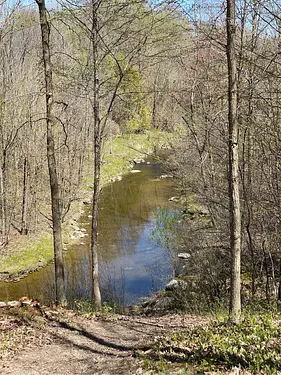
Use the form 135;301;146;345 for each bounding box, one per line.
0;132;169;281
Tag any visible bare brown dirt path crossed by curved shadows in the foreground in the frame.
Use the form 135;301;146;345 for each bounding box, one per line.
0;314;205;375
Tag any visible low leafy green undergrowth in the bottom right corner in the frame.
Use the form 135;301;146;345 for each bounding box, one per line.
139;314;281;374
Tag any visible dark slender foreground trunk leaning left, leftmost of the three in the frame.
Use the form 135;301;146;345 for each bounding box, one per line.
36;0;67;306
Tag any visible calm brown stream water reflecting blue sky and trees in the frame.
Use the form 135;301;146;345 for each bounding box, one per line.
0;159;177;305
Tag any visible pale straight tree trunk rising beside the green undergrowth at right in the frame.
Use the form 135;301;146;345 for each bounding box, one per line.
226;0;241;323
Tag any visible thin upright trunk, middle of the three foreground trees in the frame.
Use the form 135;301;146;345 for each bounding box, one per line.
91;0;102;309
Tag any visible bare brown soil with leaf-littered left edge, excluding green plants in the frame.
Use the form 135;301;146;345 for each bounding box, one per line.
0;306;208;375
